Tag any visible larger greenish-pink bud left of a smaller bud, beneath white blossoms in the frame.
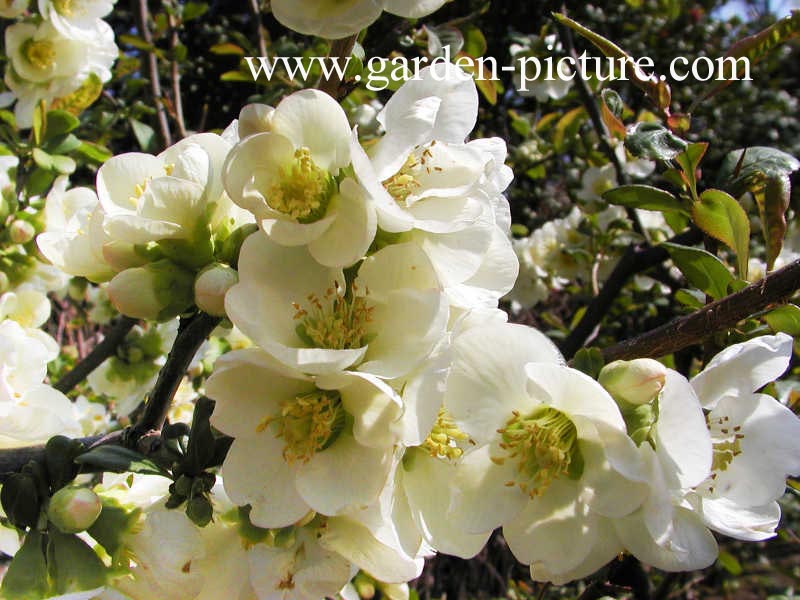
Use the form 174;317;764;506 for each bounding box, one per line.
108;259;194;321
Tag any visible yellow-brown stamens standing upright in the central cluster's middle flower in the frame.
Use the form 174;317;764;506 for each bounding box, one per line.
292;282;374;350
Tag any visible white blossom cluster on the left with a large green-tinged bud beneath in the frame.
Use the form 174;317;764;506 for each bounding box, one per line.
37;133;253;320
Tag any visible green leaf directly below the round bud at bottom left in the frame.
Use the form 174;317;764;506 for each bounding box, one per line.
47;527;108;594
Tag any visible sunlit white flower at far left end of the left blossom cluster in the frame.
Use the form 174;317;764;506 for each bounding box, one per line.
36;176;119;282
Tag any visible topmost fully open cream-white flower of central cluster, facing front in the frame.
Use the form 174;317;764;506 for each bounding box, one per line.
225;90;377;267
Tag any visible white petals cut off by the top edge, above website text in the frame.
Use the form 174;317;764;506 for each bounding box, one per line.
272;0;445;39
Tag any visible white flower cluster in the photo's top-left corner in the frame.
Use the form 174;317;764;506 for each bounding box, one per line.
0;0;119;129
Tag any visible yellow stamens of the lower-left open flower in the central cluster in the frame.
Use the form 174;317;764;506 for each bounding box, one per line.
256;390;345;465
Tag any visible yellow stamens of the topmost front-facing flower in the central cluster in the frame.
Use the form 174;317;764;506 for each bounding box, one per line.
266;147;336;223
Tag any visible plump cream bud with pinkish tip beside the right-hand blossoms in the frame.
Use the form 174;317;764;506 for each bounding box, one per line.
598;358;667;405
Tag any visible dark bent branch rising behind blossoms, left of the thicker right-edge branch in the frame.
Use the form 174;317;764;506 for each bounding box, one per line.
561;229;702;358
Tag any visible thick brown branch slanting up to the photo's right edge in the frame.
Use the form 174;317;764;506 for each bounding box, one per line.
603;260;800;362
